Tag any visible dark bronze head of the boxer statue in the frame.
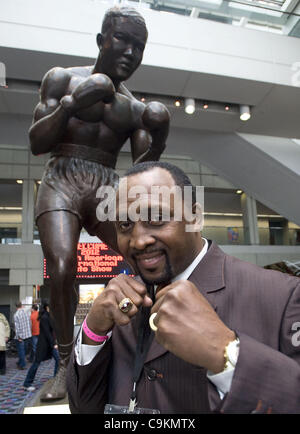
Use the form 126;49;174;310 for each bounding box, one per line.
97;7;148;81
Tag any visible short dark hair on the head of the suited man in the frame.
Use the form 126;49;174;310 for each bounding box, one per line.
124;161;196;205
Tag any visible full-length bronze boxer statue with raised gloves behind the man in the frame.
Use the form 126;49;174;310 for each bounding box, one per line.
29;7;170;400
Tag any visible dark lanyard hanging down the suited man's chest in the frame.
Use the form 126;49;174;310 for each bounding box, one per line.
128;285;154;413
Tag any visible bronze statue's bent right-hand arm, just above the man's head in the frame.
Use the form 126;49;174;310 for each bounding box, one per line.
131;102;170;164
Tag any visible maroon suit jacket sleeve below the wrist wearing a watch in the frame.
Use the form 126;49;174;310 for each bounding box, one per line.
220;284;300;413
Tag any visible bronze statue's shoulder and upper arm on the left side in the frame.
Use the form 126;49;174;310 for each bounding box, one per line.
29;68;70;155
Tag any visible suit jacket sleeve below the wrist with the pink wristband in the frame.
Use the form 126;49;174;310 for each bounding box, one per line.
67;339;112;414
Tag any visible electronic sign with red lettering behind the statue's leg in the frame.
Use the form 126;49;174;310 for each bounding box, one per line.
44;243;132;279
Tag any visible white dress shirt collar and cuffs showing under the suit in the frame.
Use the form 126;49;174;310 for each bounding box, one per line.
75;238;238;399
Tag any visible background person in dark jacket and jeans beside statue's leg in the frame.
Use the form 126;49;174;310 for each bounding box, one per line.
23;301;59;399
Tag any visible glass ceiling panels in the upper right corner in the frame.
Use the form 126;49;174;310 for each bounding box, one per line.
126;0;300;38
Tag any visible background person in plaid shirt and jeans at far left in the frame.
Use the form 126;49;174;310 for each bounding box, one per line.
14;301;31;370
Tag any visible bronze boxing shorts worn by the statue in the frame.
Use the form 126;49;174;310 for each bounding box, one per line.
35;145;119;235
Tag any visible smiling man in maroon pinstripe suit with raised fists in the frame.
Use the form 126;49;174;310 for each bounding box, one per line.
68;162;300;413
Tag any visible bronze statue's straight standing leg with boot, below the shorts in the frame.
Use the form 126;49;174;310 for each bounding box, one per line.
37;211;81;400
